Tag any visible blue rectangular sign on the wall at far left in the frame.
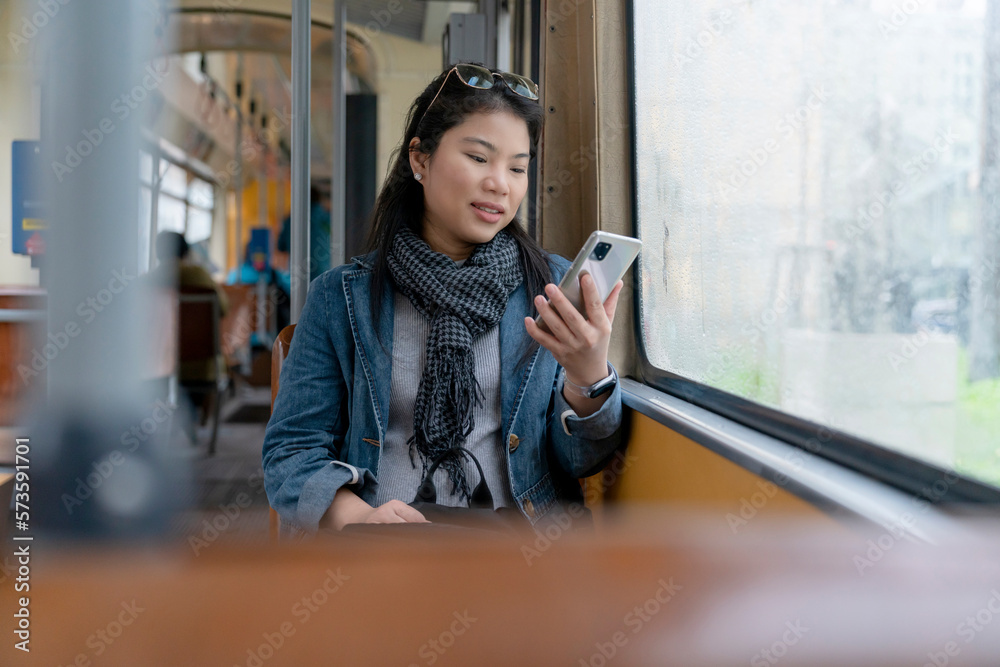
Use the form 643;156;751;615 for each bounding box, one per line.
11;141;45;256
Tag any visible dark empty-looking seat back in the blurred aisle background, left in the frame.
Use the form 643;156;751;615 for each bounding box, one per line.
177;287;229;456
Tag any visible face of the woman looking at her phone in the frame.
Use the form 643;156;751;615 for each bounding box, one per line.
410;112;531;260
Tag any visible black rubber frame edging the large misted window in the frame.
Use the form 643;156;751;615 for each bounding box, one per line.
625;0;1000;505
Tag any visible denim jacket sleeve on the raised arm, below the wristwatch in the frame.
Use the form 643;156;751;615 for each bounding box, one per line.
548;372;623;478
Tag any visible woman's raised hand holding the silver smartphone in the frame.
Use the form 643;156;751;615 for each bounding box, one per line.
524;274;623;387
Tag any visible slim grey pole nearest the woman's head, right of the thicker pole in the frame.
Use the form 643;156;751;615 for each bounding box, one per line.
330;0;347;268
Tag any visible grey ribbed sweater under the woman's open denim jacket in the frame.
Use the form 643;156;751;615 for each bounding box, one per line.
375;292;515;507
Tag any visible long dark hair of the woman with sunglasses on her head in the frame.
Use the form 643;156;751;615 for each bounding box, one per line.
367;63;552;363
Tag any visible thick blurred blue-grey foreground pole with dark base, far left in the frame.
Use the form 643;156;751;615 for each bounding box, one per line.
36;0;187;539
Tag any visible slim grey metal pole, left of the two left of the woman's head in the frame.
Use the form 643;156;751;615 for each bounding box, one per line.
289;0;312;324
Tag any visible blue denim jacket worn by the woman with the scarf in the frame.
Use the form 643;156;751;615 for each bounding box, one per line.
263;253;622;532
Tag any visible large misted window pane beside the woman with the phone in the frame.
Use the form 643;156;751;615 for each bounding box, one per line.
632;0;1000;485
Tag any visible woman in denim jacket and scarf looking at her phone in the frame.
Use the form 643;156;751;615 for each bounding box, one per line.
263;64;622;532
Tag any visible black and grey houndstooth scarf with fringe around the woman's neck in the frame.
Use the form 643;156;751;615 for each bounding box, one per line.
386;228;523;498
